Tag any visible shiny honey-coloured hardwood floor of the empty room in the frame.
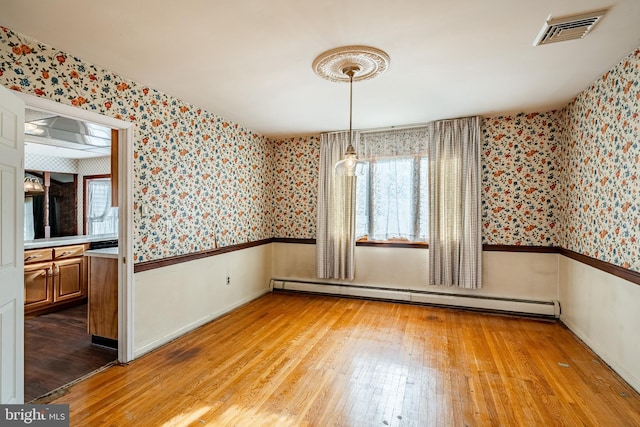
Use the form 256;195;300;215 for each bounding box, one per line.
47;293;640;426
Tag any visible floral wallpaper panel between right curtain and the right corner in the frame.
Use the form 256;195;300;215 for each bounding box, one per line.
482;111;562;246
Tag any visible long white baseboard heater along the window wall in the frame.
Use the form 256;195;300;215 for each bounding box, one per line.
271;279;560;318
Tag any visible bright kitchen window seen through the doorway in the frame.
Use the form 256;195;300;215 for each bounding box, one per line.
85;178;118;235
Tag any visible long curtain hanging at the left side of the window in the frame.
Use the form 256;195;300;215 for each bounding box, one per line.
316;132;359;280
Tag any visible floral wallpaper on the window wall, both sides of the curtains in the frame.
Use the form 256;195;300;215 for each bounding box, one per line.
274;111;562;246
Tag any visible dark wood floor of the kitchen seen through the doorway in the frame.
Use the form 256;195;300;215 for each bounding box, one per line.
24;304;118;402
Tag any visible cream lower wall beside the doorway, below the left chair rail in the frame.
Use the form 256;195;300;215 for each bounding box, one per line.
133;244;272;357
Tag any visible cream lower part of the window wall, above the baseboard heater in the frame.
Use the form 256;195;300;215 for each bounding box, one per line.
273;243;558;301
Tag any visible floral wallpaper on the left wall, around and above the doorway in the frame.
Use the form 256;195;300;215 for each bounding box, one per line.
0;27;273;262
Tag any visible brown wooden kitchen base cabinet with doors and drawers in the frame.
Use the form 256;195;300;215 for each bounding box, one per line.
24;244;89;314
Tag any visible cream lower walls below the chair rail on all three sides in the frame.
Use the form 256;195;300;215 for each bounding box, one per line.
134;243;640;390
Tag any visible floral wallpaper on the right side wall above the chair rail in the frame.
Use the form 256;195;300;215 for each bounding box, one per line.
560;49;640;271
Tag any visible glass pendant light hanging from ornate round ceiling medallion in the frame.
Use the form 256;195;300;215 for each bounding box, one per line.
313;46;390;176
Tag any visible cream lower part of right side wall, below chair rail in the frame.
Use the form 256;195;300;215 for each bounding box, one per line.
559;256;640;390
